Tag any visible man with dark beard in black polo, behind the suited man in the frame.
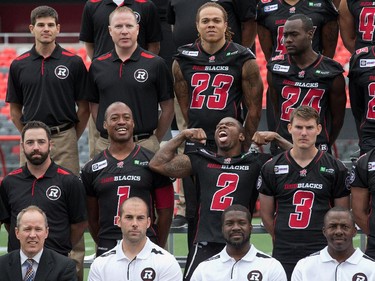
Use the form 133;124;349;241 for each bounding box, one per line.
0;121;87;256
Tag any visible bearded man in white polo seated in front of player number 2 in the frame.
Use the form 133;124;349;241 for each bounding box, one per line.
191;204;286;281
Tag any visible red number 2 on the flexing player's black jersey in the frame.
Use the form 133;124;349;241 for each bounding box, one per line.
210;173;239;211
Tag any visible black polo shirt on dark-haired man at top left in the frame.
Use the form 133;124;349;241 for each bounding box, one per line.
6;44;88;126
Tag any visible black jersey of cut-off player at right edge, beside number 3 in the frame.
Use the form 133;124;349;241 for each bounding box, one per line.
351;149;375;258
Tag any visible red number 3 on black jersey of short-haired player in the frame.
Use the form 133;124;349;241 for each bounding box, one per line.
289;190;315;229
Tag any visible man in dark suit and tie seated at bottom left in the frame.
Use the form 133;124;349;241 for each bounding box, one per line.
0;205;77;281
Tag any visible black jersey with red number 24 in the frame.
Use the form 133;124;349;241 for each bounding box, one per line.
267;54;344;148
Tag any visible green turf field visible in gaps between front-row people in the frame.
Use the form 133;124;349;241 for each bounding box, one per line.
0;218;366;280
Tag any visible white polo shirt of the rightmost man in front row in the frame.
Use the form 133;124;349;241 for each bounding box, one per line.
292;246;375;281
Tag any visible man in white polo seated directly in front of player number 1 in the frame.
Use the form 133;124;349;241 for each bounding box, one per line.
88;197;182;281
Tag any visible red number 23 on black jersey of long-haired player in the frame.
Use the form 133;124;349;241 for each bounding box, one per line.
190;72;233;110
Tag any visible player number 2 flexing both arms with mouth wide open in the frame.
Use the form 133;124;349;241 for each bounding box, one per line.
150;117;291;280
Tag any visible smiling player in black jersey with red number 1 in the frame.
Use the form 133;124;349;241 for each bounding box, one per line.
81;102;174;256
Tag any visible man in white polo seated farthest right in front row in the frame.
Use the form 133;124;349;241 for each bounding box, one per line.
292;207;375;281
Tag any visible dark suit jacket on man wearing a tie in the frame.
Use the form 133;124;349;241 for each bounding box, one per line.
0;248;77;281
